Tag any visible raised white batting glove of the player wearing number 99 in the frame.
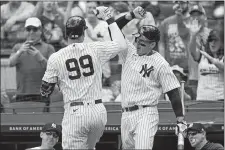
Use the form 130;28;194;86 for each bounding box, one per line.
93;6;113;21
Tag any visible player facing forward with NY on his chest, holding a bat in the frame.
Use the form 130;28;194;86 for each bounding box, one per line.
113;7;187;150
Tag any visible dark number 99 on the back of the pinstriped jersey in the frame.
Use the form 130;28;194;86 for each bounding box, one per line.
66;55;94;80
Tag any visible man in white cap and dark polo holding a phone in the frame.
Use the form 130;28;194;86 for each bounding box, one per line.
9;17;55;101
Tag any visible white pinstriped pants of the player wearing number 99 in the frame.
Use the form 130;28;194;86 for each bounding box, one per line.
62;103;107;150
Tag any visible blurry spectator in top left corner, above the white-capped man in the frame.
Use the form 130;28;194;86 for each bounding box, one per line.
1;1;34;48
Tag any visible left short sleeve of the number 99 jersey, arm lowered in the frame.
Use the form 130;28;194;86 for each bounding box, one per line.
42;53;58;83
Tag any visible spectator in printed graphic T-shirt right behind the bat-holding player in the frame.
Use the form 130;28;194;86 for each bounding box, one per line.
159;1;198;99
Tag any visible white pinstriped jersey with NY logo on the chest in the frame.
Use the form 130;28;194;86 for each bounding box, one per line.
120;40;180;107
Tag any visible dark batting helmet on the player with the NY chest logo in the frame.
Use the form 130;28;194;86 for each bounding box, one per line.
135;25;160;42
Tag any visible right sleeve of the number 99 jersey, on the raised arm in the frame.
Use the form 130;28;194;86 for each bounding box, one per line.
93;41;122;64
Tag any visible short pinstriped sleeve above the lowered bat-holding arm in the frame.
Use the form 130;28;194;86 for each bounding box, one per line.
158;63;180;93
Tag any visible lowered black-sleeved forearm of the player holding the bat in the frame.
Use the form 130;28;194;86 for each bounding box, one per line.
167;88;184;117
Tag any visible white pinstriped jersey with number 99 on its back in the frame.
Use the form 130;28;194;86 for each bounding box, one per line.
43;42;120;104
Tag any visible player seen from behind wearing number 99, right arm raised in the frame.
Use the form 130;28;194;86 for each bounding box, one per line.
41;6;127;150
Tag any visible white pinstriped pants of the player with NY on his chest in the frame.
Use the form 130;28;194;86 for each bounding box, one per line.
121;106;159;150
